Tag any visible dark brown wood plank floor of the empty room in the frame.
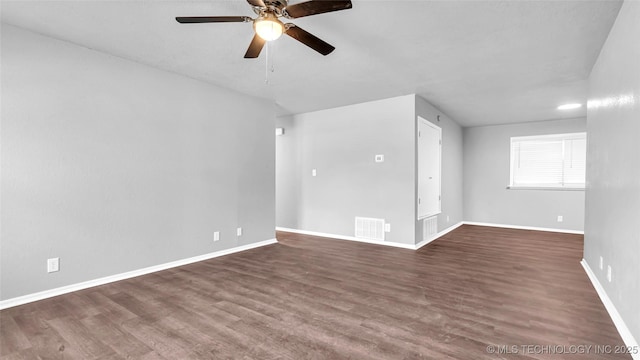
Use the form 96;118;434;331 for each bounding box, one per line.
0;225;631;360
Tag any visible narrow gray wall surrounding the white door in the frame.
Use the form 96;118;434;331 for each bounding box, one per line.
416;96;464;238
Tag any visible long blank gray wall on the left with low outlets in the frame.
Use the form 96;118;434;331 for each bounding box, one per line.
0;25;275;299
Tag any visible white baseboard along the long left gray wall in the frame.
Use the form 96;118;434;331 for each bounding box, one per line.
0;239;278;310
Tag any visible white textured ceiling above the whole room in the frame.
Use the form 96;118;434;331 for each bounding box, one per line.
1;0;621;126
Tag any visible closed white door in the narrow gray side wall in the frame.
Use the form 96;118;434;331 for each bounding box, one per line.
418;116;442;219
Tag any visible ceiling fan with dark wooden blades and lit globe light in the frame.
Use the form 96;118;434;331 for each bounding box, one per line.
176;0;352;59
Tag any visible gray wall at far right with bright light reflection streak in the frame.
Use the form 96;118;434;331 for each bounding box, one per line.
584;1;640;341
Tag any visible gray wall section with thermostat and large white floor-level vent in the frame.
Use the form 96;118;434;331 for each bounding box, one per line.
276;95;415;244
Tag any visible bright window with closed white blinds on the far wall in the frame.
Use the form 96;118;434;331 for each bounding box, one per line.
509;133;587;189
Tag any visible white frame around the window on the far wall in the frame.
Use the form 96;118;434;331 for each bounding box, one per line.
507;132;587;191
